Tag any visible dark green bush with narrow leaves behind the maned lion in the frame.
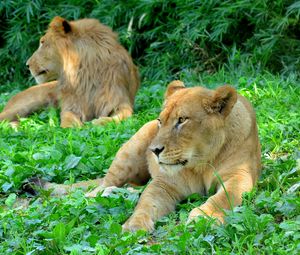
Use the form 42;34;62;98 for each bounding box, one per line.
0;0;300;87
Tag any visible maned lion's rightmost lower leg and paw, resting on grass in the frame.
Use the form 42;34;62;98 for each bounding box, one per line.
92;105;133;126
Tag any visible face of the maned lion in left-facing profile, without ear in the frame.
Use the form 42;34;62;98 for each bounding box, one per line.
26;34;61;83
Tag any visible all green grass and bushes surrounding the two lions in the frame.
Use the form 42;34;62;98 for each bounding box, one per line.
0;0;300;255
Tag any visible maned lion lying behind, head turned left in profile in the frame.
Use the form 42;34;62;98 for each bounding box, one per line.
0;17;139;127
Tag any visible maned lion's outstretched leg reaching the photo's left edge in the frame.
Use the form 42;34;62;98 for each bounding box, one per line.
0;81;58;121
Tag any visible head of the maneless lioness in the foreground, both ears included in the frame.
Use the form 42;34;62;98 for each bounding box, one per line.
150;81;237;173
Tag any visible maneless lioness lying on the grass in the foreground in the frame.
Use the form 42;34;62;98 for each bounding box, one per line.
26;81;261;231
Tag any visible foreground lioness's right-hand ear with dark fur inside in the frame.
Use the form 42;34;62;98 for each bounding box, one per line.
204;85;237;117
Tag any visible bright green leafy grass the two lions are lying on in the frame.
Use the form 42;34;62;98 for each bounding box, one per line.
0;68;300;255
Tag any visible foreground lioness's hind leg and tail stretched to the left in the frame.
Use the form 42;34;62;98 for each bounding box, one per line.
29;120;157;197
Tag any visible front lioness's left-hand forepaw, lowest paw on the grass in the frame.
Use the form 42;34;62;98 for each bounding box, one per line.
122;215;154;232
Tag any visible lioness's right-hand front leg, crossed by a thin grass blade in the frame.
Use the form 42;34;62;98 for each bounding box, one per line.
188;171;254;223
